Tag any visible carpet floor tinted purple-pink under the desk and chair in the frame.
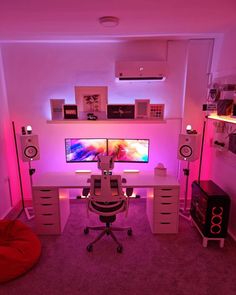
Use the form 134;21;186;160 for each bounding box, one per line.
0;199;236;295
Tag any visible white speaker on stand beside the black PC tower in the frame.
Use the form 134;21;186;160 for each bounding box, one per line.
177;134;201;162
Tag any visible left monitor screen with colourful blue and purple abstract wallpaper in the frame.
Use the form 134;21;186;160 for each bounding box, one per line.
65;138;107;163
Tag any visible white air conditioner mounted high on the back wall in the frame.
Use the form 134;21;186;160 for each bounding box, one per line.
115;61;167;81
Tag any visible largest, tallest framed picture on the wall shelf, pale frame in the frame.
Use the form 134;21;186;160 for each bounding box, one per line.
75;86;108;119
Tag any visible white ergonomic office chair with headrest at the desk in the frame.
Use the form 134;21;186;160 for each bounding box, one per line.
84;156;132;253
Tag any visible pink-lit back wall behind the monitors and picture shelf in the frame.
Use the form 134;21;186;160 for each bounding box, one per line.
2;40;213;206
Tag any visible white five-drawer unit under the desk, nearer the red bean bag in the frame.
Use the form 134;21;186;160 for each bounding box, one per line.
33;187;70;235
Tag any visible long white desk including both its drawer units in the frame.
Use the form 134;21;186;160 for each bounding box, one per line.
33;172;179;234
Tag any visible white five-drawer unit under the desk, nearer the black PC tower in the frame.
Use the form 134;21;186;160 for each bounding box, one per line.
146;185;179;234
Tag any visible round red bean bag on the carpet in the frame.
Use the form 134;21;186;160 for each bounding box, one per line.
0;220;41;283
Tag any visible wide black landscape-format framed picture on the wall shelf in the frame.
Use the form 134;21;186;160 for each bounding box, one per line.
107;104;134;119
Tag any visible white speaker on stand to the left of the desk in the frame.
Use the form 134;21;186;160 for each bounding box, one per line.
21;134;40;162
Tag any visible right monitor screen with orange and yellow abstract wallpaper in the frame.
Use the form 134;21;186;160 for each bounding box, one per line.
108;139;149;162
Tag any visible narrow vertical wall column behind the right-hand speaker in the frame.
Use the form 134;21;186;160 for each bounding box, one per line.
180;39;214;200
